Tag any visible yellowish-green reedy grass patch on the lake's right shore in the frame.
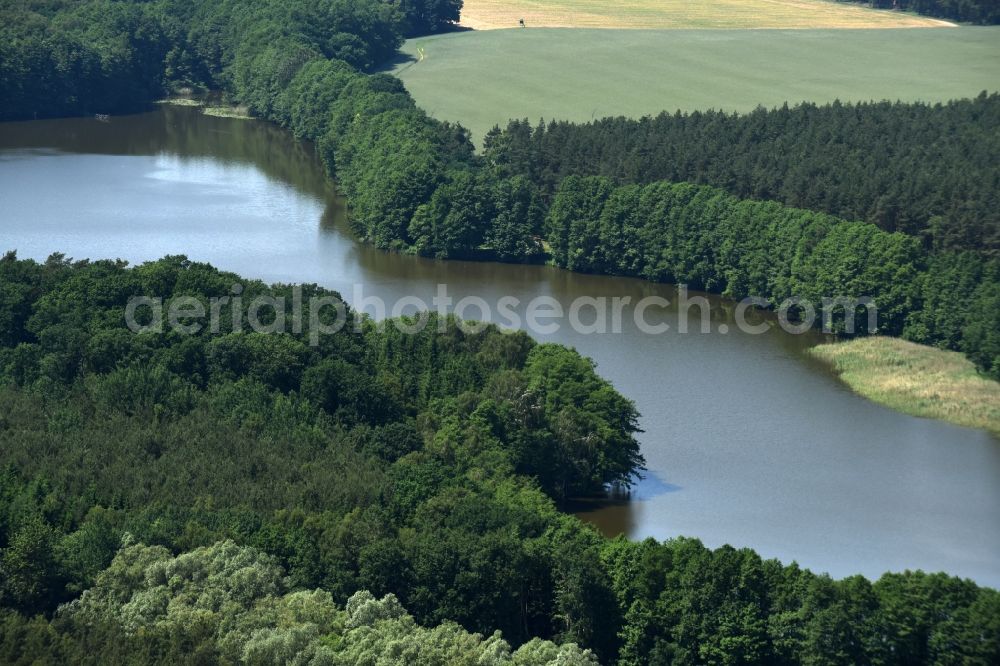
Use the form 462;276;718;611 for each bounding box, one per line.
810;336;1000;436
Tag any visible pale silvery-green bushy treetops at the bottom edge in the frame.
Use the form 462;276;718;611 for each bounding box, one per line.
0;537;598;666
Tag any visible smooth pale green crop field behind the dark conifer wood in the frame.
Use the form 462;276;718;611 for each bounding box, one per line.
390;27;1000;140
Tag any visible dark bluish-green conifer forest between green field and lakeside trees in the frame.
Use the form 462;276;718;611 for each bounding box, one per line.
485;98;1000;256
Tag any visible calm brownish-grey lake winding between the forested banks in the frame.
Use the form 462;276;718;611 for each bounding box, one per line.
0;108;1000;587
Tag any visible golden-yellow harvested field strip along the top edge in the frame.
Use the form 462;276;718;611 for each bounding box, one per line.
462;0;951;30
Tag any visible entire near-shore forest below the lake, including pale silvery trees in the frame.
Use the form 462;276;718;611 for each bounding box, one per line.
0;254;1000;664
